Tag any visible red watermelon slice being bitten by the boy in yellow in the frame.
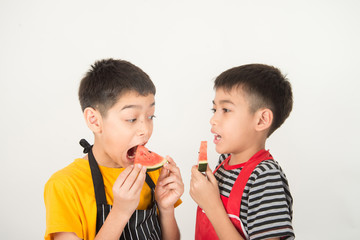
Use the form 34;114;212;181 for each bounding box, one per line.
134;145;167;172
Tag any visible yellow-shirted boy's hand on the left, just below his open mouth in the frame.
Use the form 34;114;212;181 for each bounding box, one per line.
112;164;146;218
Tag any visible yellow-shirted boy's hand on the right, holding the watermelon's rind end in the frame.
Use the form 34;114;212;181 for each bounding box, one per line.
155;156;184;211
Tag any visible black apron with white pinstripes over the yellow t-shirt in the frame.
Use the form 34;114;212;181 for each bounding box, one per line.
80;139;161;240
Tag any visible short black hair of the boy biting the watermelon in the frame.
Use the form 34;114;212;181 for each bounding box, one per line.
79;58;156;116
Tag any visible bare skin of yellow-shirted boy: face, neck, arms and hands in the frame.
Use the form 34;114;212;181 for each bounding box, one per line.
53;92;184;240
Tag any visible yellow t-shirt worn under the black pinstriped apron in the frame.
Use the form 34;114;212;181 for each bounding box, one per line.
44;158;181;240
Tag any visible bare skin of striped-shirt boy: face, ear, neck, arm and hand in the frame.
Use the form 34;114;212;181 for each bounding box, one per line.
190;88;279;239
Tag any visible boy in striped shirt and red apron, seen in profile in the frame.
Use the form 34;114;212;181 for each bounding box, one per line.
190;64;295;240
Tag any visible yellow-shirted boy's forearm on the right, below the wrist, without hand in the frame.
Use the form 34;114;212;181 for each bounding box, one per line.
159;208;180;240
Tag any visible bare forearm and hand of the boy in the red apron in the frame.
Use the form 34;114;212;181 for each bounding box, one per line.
190;166;243;240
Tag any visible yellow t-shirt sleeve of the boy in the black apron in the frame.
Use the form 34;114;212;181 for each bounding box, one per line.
44;178;83;240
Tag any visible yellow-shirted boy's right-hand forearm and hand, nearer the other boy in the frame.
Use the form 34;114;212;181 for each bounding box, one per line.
155;157;184;240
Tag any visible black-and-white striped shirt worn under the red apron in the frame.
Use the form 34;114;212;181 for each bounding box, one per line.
215;155;295;240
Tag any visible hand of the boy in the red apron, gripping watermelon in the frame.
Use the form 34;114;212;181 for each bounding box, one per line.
190;165;222;212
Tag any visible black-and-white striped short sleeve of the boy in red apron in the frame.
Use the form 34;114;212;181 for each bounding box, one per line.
246;163;294;240
